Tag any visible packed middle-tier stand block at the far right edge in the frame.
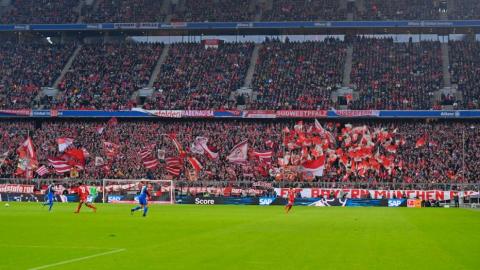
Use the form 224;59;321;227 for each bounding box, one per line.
449;41;480;109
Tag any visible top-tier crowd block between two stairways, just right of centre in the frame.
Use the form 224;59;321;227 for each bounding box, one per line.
262;0;347;21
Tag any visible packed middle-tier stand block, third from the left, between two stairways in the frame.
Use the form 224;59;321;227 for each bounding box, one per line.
144;43;254;109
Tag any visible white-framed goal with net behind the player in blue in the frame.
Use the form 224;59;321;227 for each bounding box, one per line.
102;179;175;204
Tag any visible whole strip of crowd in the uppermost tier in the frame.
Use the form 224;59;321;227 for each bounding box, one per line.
0;0;479;23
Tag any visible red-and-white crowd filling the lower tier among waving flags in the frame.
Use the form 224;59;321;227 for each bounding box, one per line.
0;120;480;190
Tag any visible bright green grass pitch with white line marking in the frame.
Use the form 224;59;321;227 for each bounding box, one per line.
0;203;480;270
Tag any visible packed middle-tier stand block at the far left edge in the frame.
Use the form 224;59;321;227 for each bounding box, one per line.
0;42;74;109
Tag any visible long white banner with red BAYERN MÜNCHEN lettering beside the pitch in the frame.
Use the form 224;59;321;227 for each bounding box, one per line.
275;188;474;201
